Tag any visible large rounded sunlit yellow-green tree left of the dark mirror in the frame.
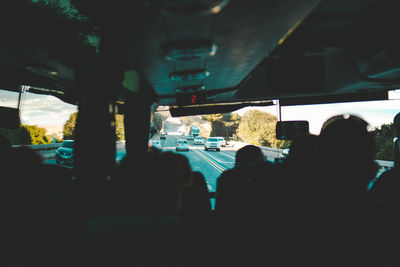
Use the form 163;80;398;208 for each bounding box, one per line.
237;110;289;148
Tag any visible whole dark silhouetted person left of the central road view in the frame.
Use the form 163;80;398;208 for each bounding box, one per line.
87;152;195;266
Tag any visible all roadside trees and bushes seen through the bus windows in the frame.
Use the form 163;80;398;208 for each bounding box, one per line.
0;110;395;161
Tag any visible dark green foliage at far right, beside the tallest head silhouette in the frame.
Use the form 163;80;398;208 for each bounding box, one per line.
373;123;395;161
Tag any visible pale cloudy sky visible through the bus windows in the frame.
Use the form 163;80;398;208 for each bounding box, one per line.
0;90;400;134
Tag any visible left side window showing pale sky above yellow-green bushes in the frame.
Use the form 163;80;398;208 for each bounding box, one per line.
0;87;77;160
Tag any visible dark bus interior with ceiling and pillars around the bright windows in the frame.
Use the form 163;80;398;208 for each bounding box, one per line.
0;0;400;266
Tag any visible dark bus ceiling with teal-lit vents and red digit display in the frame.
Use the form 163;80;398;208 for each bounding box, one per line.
0;0;400;108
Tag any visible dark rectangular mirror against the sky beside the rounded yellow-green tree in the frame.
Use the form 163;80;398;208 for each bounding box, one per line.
276;121;309;140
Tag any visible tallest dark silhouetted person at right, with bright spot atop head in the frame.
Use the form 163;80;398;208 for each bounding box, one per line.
316;115;379;266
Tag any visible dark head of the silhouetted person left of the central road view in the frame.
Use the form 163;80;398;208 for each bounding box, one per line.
124;151;191;215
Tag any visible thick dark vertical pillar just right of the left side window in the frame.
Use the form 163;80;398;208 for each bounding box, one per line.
74;31;123;218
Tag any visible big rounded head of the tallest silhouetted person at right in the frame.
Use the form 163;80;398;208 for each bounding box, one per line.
317;115;378;203
